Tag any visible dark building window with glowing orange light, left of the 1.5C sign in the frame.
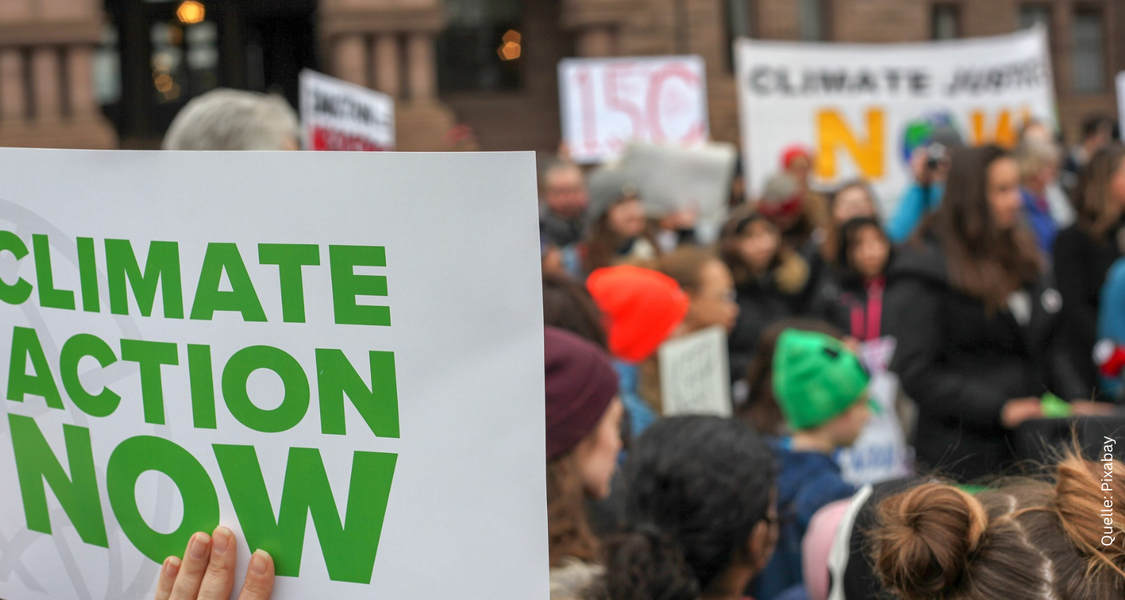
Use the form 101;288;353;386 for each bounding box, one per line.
438;0;525;93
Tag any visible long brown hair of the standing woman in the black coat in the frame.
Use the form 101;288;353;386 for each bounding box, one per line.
918;145;1042;311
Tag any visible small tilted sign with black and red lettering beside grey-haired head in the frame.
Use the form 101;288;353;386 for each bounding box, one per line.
300;69;395;151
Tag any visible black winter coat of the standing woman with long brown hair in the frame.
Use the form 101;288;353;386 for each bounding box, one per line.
884;236;1085;481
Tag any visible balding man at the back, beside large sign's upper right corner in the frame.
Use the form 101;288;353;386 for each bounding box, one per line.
539;160;590;250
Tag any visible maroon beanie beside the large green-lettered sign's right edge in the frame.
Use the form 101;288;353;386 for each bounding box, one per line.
543;328;618;460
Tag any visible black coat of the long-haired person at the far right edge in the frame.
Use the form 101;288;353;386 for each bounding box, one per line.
1054;225;1121;396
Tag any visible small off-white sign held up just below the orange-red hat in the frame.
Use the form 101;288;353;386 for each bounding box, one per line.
658;326;731;417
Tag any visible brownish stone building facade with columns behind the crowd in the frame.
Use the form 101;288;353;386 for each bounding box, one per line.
0;0;1125;153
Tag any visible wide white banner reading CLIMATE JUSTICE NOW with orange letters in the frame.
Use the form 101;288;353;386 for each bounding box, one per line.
735;28;1055;215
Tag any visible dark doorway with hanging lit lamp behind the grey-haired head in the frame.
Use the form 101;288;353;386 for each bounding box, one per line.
102;0;317;147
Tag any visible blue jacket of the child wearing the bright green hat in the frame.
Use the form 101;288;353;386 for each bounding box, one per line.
755;444;855;600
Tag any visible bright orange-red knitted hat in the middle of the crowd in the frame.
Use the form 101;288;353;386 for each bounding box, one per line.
586;266;689;362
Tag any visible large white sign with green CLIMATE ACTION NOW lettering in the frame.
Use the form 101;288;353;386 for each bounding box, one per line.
0;149;548;600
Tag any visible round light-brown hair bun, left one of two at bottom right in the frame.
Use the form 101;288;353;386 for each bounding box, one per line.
874;483;988;600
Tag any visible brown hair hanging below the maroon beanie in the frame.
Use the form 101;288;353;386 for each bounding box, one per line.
547;453;601;567
